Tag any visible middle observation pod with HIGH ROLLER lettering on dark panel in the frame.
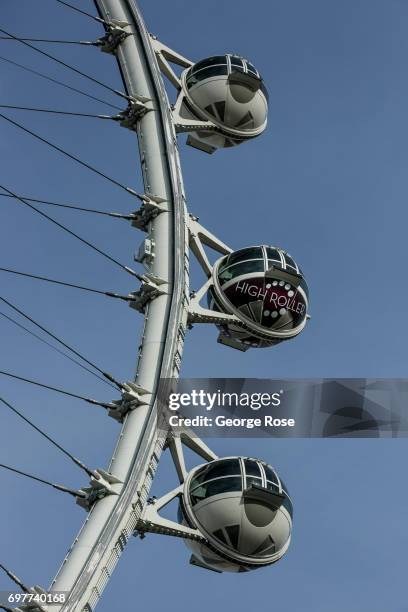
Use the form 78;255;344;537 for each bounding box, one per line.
208;245;309;350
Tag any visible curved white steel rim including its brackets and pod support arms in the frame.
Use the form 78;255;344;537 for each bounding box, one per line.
20;0;296;612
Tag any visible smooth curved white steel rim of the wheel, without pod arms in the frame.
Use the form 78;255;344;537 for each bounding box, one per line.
50;0;189;612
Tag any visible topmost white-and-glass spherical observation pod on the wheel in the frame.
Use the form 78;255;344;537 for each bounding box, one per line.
180;54;268;153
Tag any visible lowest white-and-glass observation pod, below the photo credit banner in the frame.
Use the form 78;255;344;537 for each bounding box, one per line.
180;457;293;572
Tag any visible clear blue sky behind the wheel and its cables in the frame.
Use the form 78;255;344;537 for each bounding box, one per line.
0;0;408;612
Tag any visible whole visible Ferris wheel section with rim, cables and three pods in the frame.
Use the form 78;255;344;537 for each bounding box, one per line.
0;0;309;612
